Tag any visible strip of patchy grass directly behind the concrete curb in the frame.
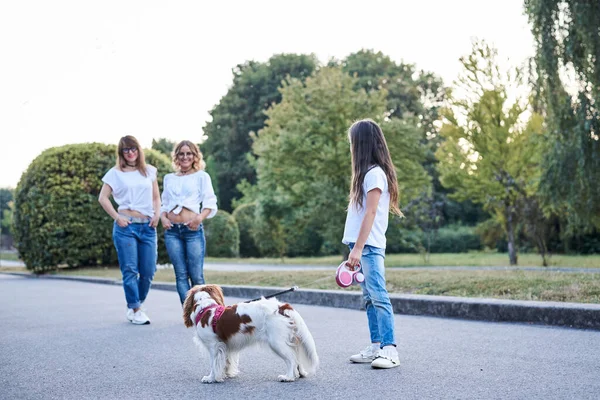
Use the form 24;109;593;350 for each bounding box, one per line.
0;267;600;304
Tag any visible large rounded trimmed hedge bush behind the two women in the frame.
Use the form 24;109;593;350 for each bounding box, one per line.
13;143;171;272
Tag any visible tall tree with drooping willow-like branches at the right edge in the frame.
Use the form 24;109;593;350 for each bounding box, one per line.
525;0;600;230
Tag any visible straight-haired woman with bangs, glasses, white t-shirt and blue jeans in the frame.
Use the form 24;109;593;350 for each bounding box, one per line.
98;136;160;325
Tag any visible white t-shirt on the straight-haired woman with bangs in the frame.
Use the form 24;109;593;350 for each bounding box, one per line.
102;165;156;217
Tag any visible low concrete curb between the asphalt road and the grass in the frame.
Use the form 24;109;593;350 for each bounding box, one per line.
1;272;600;330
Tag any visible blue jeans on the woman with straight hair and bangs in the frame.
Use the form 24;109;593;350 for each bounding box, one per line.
113;222;158;308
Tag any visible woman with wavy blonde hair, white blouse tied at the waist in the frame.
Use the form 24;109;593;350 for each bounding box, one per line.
160;140;217;304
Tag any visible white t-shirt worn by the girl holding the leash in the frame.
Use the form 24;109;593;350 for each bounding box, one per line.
342;166;390;249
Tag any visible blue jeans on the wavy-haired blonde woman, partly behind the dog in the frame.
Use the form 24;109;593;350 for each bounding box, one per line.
165;224;206;304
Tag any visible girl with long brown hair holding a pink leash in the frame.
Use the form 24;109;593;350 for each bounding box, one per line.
342;119;402;368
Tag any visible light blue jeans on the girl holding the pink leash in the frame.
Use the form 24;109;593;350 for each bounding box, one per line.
349;243;396;348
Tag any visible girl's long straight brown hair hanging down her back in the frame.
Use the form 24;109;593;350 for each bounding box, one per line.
348;119;403;216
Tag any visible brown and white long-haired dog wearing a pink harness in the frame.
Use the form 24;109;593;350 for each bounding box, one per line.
183;285;319;383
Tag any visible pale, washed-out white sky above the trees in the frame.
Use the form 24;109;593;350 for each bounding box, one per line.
0;0;533;187
